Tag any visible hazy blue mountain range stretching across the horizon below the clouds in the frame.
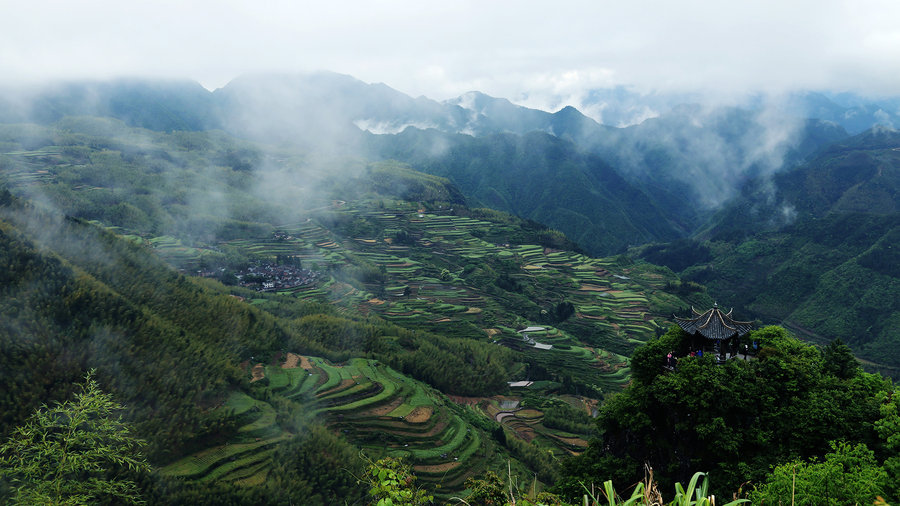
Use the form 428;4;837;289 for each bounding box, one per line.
0;72;900;254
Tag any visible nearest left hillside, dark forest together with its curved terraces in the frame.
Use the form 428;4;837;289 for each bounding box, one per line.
0;193;554;504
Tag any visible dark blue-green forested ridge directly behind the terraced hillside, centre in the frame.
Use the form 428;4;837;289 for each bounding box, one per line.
373;129;679;254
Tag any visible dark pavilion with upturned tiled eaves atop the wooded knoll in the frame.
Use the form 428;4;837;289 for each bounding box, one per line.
675;304;753;362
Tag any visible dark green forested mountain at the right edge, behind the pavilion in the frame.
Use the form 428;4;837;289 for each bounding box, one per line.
639;128;900;374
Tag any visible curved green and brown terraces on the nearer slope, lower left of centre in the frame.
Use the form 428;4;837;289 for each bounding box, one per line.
161;354;496;490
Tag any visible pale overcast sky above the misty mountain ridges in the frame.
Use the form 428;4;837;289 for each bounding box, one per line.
0;0;900;109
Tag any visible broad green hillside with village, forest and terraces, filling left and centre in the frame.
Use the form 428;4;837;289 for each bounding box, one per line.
0;118;709;504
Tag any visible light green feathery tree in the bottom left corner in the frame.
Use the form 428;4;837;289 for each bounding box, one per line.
0;370;150;504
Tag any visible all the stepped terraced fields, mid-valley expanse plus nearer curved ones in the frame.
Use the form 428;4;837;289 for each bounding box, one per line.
155;202;704;490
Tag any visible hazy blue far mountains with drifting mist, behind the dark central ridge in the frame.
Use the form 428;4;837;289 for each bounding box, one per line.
436;93;847;235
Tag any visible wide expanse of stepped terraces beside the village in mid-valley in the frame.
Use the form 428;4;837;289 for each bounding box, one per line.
144;201;688;396
